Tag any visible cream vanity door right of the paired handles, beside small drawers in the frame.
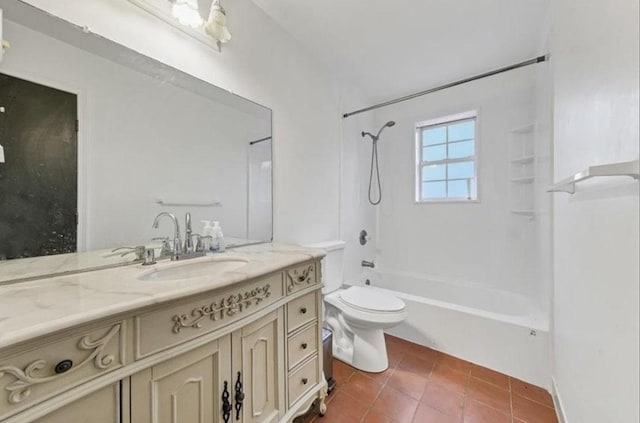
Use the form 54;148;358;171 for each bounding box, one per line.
232;308;286;423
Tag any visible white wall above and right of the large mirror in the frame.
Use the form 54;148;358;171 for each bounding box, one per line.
12;0;341;247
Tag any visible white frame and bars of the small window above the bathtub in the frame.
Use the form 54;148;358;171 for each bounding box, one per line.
414;110;480;204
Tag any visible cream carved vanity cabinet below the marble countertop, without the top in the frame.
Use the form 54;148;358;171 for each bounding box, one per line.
0;260;326;423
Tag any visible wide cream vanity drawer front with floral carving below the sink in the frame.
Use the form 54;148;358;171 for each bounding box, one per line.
135;272;284;359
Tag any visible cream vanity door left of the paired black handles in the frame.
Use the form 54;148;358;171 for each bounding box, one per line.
131;335;233;423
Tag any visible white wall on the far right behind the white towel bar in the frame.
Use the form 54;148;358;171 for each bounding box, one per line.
551;0;640;423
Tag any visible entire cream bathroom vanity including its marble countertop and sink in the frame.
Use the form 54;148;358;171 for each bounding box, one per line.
0;244;326;423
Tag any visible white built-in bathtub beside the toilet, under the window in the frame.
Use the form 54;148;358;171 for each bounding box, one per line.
351;272;550;388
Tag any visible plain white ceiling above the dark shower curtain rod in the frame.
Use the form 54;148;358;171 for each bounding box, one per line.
254;0;549;101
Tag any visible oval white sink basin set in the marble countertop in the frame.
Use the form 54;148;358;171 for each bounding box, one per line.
138;257;249;282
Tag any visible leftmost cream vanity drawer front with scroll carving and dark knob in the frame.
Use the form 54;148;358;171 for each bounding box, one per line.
0;321;126;421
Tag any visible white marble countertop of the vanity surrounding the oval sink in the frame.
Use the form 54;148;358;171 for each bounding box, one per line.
0;244;325;348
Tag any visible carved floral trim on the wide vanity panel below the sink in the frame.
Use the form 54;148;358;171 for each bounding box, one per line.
172;284;271;333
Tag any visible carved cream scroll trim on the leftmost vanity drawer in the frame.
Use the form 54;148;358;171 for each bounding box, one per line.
0;323;121;404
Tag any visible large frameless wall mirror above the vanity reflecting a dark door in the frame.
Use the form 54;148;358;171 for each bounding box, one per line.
0;0;272;283
